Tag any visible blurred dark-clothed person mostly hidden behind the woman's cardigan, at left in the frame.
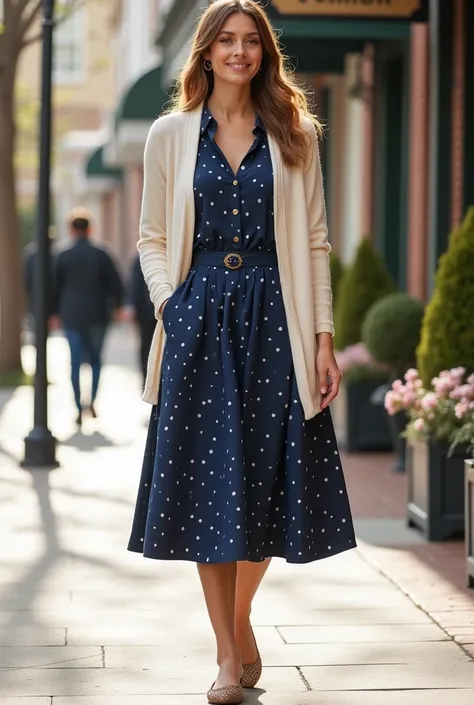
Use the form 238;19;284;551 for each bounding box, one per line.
129;255;156;383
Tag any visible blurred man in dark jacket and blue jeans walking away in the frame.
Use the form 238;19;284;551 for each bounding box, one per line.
51;208;123;425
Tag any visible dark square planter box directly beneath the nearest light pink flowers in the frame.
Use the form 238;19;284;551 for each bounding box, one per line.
406;441;466;541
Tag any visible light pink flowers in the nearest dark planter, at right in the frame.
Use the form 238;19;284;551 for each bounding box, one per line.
385;367;474;444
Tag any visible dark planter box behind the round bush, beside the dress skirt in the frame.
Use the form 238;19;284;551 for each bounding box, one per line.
345;379;393;453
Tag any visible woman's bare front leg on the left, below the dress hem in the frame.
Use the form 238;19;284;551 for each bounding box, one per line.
198;563;241;688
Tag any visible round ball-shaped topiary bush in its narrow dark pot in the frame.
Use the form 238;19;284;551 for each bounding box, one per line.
362;292;424;472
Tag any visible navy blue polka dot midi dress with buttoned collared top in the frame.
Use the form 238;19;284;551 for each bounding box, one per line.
129;108;356;563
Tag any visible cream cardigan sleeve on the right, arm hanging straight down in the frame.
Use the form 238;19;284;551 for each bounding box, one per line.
304;124;334;335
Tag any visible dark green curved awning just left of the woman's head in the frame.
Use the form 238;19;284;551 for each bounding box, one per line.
115;66;170;129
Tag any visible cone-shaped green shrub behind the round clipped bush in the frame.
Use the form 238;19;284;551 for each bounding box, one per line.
334;239;395;350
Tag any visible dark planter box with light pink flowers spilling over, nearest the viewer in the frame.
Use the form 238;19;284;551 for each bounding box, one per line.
385;367;474;541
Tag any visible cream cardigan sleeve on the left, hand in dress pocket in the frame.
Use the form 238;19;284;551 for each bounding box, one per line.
138;120;173;319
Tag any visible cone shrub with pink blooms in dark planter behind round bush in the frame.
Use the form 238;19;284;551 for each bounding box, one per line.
334;239;395;452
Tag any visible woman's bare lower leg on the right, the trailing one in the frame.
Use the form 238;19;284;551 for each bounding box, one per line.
234;558;271;663
